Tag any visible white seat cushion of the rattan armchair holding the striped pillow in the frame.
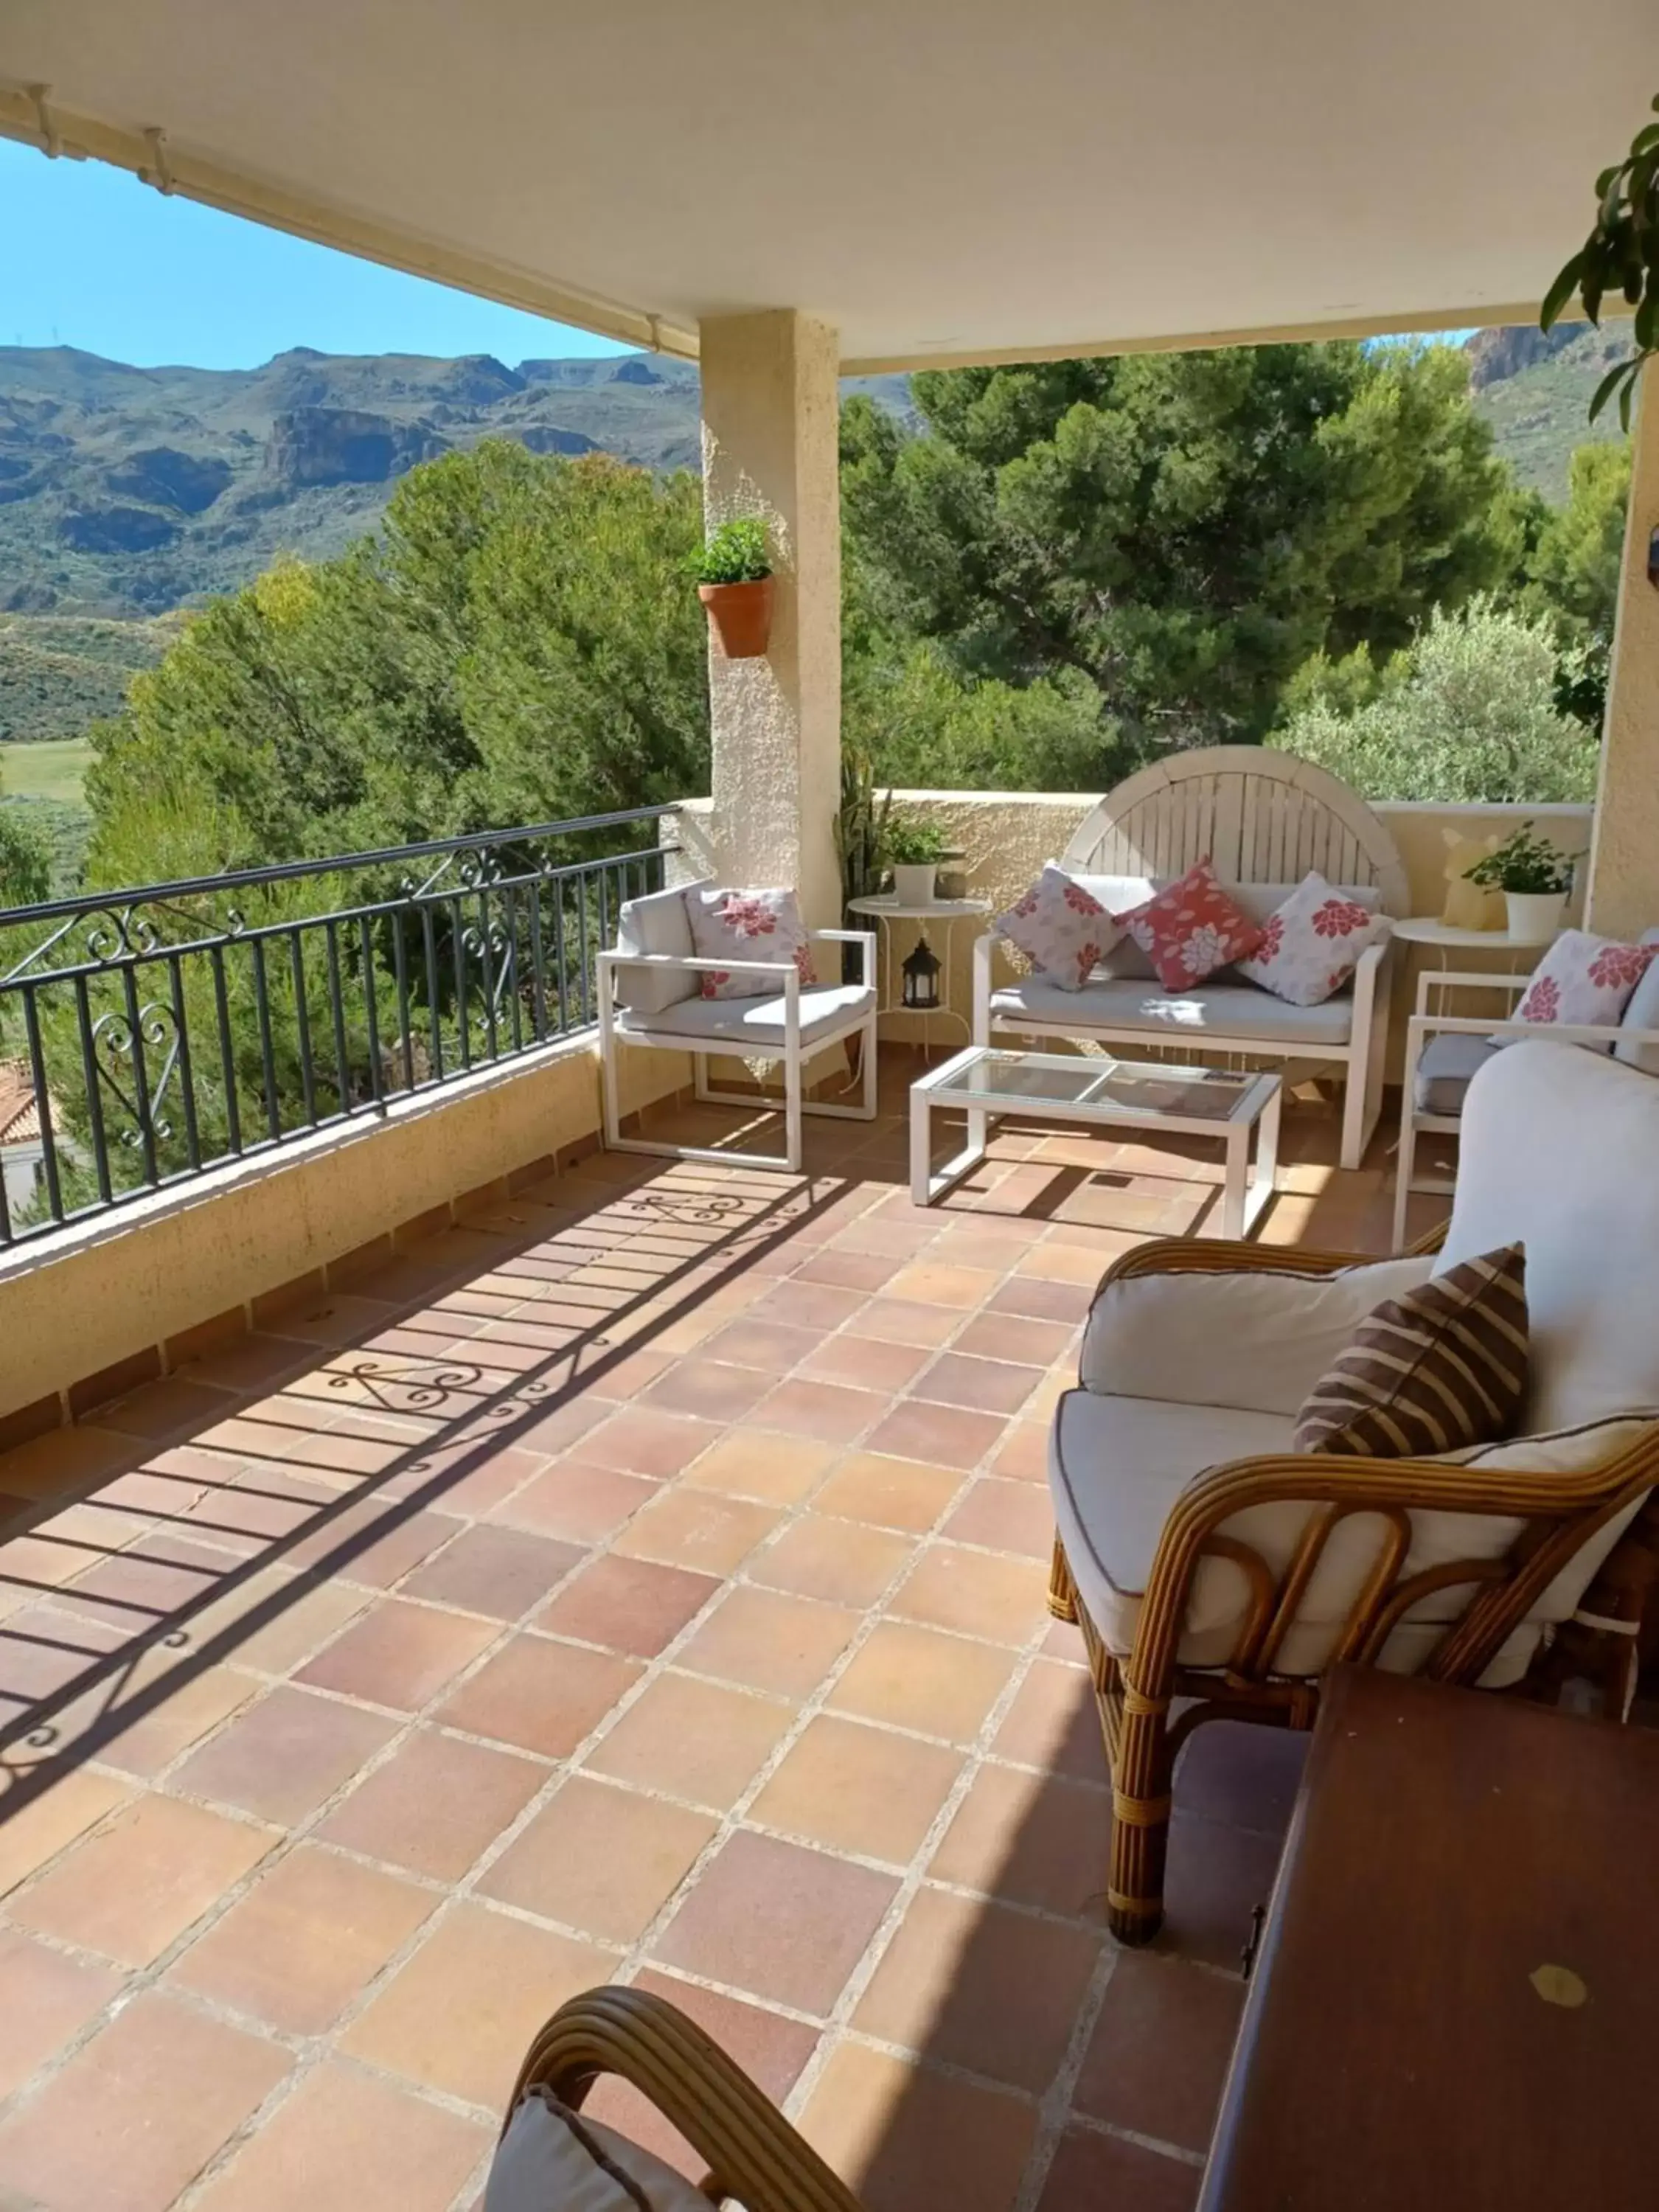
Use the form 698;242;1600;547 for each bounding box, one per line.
1048;1389;1652;1690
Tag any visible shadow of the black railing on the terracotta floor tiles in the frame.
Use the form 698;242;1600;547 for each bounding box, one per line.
0;1157;872;1820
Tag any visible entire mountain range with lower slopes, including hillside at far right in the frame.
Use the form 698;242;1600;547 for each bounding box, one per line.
0;325;1626;741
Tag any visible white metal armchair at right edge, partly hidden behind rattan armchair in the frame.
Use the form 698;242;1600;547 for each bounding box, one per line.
1394;929;1659;1245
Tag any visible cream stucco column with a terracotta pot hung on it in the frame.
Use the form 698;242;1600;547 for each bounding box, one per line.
701;307;841;929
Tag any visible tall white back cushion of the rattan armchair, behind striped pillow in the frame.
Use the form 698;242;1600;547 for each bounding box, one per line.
1436;1040;1659;1429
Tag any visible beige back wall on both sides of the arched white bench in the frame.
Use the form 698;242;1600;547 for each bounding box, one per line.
883;792;1601;1082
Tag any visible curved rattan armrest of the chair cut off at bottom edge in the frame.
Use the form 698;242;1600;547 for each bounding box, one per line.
509;1989;860;2212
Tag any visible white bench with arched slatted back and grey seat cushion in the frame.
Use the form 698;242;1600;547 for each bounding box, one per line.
973;745;1409;1168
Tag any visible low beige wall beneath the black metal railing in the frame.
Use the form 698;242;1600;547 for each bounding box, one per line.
0;1037;690;1440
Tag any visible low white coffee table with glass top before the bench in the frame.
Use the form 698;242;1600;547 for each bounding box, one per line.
909;1044;1283;1237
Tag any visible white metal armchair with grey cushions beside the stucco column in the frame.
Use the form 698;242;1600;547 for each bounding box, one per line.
597;878;876;1175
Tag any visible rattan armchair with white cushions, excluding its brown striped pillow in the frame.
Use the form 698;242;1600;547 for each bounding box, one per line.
1048;1042;1659;1942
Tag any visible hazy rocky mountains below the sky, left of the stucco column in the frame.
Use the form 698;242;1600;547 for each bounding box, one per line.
0;345;907;617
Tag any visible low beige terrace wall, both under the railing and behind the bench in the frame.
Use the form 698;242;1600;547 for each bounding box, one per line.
0;792;1590;1449
